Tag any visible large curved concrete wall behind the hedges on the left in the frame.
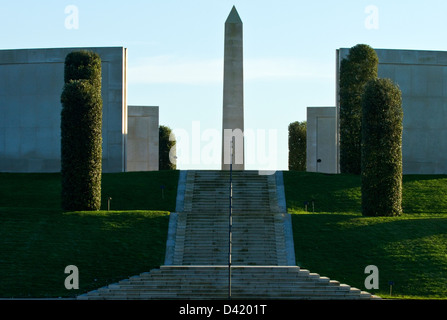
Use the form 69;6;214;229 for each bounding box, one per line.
0;47;127;172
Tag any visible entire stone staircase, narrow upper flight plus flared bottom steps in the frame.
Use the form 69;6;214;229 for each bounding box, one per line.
78;170;378;300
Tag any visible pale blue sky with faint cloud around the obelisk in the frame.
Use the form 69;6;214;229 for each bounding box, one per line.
0;0;447;170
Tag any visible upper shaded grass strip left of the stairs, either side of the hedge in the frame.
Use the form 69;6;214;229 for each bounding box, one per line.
0;170;179;212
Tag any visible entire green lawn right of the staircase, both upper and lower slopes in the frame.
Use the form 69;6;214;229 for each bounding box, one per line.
284;172;447;299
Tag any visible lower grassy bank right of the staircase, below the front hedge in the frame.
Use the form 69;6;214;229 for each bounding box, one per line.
292;213;447;298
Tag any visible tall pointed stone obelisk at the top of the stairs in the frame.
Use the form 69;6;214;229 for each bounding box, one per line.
222;6;244;170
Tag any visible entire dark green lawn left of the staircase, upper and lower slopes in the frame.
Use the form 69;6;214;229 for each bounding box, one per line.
0;171;178;298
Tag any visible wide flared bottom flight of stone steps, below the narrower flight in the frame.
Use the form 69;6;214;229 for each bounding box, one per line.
80;266;373;300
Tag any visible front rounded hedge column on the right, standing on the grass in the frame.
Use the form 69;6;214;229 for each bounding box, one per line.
361;79;403;216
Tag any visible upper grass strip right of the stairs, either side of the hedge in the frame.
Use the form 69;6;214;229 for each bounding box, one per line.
284;171;447;214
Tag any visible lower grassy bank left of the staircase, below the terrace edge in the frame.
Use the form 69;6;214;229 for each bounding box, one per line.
0;208;169;298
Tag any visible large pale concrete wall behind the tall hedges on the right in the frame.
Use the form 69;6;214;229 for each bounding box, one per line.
337;48;447;174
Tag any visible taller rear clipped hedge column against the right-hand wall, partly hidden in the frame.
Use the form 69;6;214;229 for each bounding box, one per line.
339;44;379;174
